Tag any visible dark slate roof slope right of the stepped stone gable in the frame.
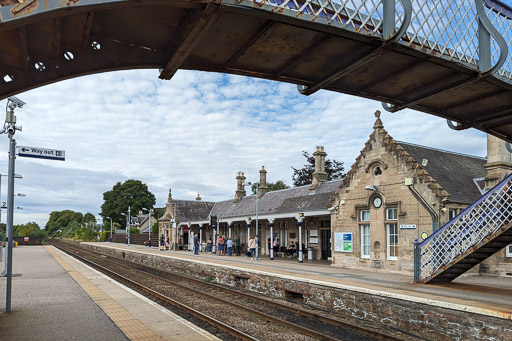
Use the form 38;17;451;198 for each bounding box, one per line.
397;141;487;204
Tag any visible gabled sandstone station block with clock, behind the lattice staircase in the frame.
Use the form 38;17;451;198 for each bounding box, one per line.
330;111;512;275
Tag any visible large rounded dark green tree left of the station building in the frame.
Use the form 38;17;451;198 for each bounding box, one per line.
100;179;156;226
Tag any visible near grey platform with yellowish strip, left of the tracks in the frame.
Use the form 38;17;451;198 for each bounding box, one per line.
0;246;218;341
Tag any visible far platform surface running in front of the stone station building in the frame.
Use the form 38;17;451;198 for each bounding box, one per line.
90;243;512;325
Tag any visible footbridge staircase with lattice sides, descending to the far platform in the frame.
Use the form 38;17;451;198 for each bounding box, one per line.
414;174;512;283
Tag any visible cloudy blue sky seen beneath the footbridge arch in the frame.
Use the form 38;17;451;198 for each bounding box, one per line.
0;70;486;227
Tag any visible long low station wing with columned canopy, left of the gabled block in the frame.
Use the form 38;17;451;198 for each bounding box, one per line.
159;147;341;260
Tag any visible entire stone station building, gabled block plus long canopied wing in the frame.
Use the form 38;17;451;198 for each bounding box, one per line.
159;111;512;275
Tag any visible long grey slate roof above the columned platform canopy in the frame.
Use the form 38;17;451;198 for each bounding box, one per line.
212;180;341;219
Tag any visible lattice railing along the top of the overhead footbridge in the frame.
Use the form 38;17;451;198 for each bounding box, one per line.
227;0;512;91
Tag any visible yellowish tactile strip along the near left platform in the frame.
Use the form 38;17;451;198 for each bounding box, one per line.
44;246;162;341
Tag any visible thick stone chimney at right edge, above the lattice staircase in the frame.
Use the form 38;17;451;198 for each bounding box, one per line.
484;134;512;189
